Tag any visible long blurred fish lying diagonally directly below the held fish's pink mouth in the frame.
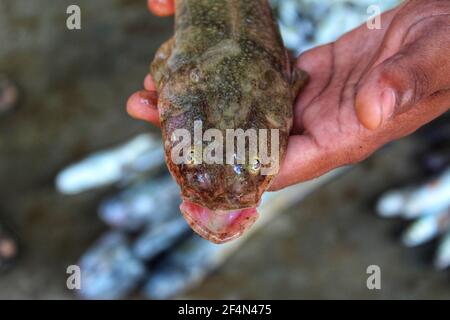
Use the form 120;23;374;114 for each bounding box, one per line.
142;168;342;299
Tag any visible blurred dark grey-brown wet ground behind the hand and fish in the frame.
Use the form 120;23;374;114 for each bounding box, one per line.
0;0;450;299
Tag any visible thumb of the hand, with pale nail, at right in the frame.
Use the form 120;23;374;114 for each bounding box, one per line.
355;17;450;130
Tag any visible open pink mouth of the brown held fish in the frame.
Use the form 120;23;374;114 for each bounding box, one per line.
180;200;259;244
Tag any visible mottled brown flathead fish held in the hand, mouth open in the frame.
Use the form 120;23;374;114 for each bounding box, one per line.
151;0;308;244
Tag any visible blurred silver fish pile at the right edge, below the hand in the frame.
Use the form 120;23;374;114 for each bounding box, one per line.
377;116;450;270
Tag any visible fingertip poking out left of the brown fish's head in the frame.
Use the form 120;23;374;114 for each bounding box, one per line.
127;90;160;126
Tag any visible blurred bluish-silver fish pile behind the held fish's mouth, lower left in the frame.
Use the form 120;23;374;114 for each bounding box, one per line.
56;134;338;299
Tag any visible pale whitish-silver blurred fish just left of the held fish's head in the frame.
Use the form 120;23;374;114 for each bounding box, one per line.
56;134;164;194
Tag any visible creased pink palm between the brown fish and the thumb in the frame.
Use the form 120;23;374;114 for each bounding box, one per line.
275;18;392;188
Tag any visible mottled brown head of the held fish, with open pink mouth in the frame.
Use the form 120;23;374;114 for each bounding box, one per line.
158;59;292;243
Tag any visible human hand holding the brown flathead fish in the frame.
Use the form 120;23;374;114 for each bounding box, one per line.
128;0;450;190
